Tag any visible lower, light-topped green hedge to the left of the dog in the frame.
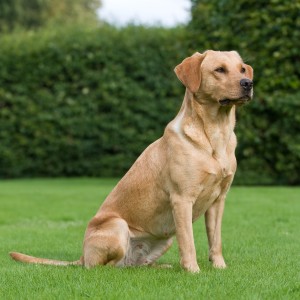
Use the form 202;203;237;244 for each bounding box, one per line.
0;26;185;177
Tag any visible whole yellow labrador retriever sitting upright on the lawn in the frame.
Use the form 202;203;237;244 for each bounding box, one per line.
10;50;253;272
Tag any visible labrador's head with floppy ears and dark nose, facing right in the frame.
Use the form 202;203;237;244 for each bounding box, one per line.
174;50;253;105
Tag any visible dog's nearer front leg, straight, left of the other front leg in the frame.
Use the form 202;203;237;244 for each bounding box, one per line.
172;196;200;273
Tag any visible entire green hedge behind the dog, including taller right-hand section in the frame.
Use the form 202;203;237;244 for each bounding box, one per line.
0;0;300;184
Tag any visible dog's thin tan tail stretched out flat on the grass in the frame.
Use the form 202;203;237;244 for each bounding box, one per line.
9;252;83;266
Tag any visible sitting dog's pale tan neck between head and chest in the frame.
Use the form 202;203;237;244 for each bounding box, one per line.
175;90;235;158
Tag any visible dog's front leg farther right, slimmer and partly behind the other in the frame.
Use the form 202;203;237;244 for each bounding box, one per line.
205;196;226;268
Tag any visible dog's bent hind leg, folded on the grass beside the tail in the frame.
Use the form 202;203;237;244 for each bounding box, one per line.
83;218;129;268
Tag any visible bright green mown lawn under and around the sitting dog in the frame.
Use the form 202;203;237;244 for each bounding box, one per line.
0;179;300;300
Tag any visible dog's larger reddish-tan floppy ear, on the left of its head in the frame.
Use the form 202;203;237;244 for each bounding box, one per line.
174;52;204;93
